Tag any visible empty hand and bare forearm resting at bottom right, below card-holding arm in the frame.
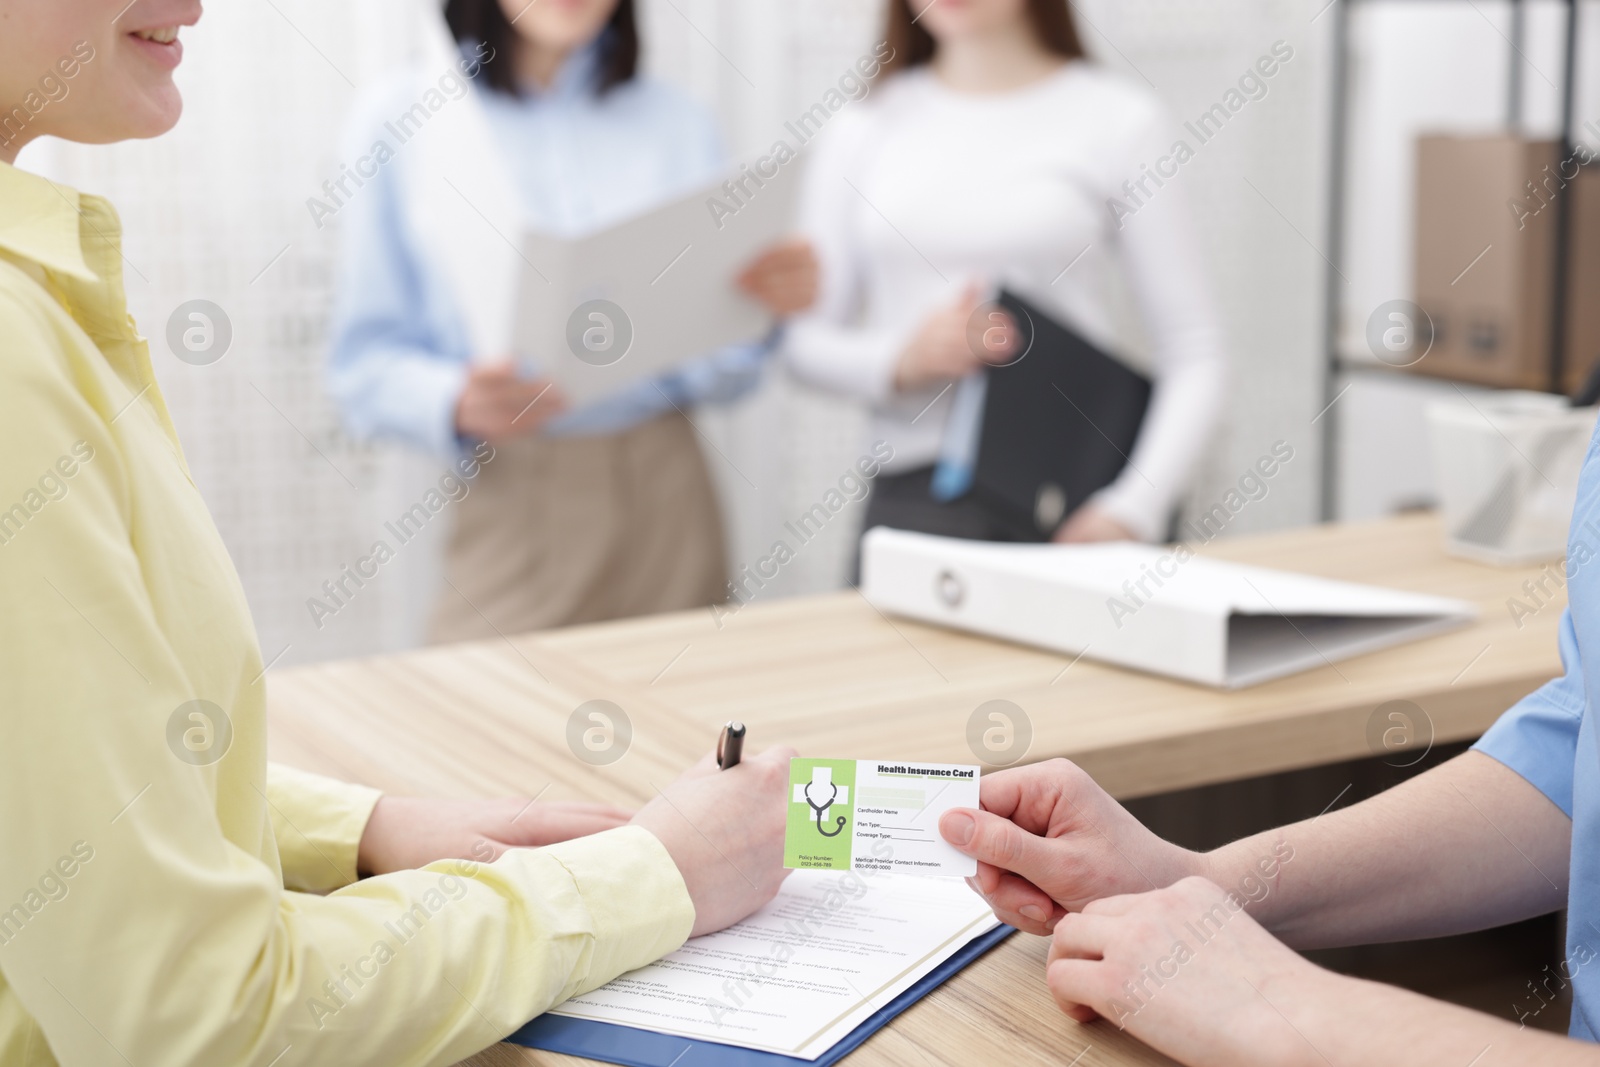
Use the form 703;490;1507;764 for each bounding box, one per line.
1046;878;1600;1067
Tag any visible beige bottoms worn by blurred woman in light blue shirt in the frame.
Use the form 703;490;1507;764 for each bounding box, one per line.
429;413;728;641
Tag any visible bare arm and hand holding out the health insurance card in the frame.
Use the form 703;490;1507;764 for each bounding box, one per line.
941;752;1571;949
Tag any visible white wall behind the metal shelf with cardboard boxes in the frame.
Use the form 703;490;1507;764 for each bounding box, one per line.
1333;0;1600;518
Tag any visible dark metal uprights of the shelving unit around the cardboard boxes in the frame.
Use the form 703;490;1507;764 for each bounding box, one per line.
1322;0;1578;522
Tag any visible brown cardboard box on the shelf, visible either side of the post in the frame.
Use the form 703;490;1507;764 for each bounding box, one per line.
1408;134;1600;392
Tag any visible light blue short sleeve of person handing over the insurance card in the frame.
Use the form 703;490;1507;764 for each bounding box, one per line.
1472;611;1587;817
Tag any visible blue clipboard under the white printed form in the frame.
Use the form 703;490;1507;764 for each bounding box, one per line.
506;925;1016;1067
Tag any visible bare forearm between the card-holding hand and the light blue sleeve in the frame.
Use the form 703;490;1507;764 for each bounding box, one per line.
1203;752;1571;949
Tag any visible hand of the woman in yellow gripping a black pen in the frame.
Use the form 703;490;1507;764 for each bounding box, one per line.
634;747;795;937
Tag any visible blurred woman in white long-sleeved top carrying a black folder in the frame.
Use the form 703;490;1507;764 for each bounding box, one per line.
786;0;1226;541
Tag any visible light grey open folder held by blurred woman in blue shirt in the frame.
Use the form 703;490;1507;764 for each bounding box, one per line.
514;162;800;406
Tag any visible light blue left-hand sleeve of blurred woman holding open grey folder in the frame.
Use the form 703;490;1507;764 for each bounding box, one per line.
328;90;469;456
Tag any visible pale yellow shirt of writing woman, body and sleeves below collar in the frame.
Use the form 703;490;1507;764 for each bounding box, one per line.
0;278;694;1067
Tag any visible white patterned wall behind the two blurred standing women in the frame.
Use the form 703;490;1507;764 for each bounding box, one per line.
22;0;1324;664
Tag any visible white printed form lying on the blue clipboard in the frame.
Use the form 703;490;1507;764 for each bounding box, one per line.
554;870;1000;1059
